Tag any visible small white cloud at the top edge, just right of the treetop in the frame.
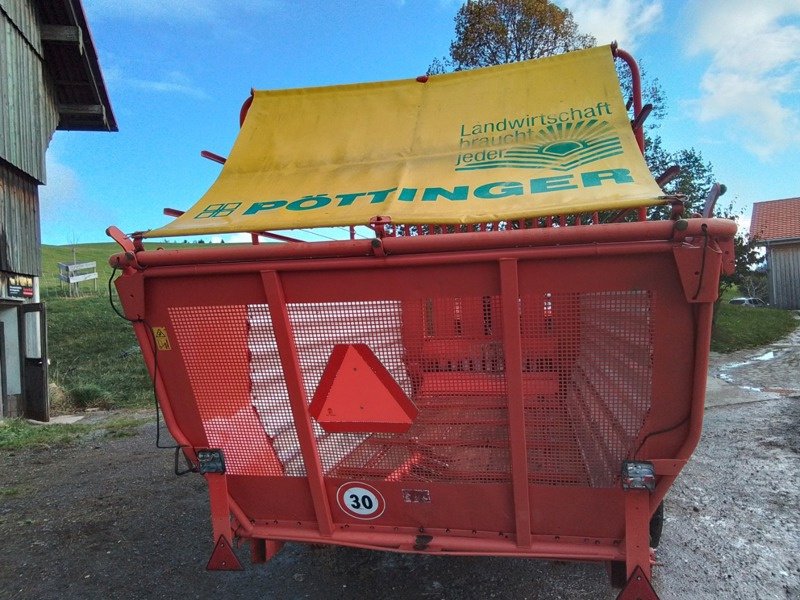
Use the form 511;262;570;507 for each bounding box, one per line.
558;0;663;51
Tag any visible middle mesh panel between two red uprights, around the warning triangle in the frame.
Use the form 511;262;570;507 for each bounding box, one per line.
288;297;509;482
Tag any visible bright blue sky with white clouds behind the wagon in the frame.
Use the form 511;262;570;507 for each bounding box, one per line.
41;0;800;244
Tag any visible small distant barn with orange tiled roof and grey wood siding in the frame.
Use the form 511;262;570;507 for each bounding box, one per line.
750;198;800;310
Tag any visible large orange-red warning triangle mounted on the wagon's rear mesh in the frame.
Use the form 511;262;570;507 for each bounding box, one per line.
309;344;418;433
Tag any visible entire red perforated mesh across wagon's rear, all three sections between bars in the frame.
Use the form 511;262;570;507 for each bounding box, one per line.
170;292;652;487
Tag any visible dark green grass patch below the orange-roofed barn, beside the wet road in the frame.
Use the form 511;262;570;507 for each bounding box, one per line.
711;299;800;352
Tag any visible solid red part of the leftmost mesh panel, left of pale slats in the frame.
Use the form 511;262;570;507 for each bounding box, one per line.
169;306;284;475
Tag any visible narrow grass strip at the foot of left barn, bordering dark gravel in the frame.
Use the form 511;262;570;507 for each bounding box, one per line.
0;417;146;450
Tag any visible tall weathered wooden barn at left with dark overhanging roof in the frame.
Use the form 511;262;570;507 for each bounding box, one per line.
0;0;117;420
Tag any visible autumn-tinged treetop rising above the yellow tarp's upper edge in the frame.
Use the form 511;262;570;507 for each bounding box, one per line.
428;0;596;73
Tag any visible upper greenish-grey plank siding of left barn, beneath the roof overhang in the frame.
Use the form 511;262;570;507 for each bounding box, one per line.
0;0;58;183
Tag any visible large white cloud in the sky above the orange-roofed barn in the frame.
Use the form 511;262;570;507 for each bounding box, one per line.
686;0;800;159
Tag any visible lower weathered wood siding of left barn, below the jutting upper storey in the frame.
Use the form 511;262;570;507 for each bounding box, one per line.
0;161;42;276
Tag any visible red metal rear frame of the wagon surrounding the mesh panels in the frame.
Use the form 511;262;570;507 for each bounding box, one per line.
111;214;735;596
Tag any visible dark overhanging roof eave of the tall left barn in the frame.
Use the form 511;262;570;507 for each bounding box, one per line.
38;0;117;131
